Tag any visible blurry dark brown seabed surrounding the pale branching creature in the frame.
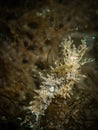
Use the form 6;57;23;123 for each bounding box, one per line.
0;0;98;130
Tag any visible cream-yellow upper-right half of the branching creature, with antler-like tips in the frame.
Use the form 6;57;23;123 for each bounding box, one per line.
54;37;94;99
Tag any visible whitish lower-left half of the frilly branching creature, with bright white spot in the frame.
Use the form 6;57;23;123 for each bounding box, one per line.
28;74;64;120
